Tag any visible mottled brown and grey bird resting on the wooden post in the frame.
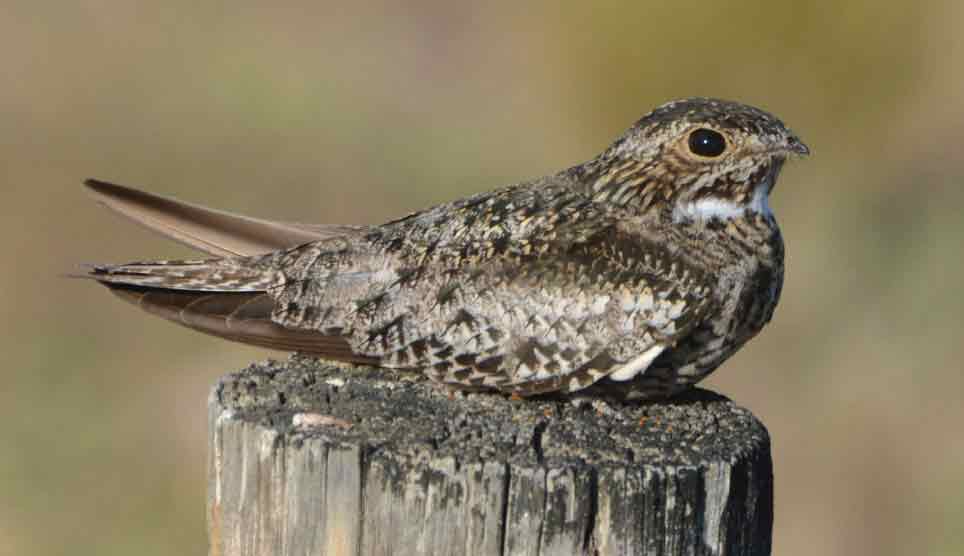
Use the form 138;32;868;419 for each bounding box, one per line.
82;97;810;400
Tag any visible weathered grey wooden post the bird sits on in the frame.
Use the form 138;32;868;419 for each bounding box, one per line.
208;357;773;556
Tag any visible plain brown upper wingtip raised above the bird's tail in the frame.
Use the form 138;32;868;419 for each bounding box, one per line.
84;179;370;257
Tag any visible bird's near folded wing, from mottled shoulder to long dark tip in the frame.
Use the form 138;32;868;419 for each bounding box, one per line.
83;179;713;395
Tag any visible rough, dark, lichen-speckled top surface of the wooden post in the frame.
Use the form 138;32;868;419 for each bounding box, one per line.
212;356;769;467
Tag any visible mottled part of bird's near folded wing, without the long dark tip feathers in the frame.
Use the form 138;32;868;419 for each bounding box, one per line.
269;192;712;395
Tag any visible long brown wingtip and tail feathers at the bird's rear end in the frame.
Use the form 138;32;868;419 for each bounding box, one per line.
82;180;376;364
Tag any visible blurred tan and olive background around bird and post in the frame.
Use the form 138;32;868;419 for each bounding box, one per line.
0;0;964;555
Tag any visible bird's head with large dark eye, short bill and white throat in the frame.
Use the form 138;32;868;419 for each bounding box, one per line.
593;98;810;220
